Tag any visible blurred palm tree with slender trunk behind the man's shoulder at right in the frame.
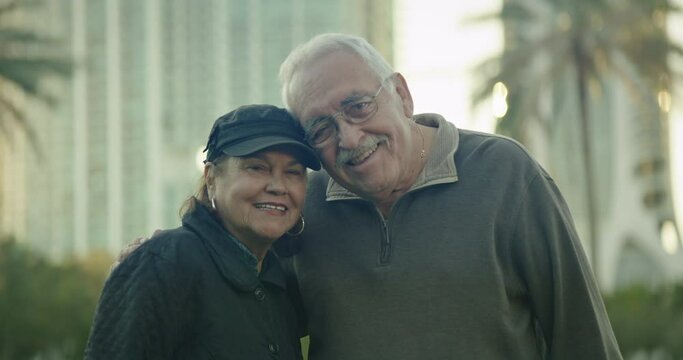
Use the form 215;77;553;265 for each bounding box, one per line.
473;0;683;274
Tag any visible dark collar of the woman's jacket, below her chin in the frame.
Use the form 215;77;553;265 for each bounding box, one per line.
183;201;286;291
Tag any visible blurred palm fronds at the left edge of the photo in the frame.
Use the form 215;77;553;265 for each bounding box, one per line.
0;1;71;155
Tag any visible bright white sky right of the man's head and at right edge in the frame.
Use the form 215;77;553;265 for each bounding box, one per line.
394;0;683;241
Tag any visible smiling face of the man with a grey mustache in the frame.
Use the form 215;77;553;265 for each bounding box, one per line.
293;51;414;201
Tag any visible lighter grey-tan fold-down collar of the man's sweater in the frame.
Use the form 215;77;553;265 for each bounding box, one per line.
326;114;460;201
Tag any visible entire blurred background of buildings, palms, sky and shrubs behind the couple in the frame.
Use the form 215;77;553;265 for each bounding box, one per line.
0;0;683;360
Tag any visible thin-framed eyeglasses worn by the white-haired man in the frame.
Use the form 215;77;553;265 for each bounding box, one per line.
306;84;384;148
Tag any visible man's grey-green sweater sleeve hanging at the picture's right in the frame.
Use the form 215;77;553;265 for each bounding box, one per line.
512;170;621;360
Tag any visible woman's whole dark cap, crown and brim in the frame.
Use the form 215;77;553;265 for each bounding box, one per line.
204;105;320;170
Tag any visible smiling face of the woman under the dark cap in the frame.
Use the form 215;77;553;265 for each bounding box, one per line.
206;149;306;244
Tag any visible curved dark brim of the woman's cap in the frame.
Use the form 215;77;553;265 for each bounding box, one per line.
222;136;320;170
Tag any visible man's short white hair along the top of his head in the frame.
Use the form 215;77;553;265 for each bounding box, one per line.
280;33;394;113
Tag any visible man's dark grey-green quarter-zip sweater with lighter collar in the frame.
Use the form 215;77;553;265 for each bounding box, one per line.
290;114;621;360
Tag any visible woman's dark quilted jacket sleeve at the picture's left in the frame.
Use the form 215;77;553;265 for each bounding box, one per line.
85;248;195;359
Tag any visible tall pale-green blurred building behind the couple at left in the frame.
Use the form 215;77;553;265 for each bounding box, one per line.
0;0;393;258
